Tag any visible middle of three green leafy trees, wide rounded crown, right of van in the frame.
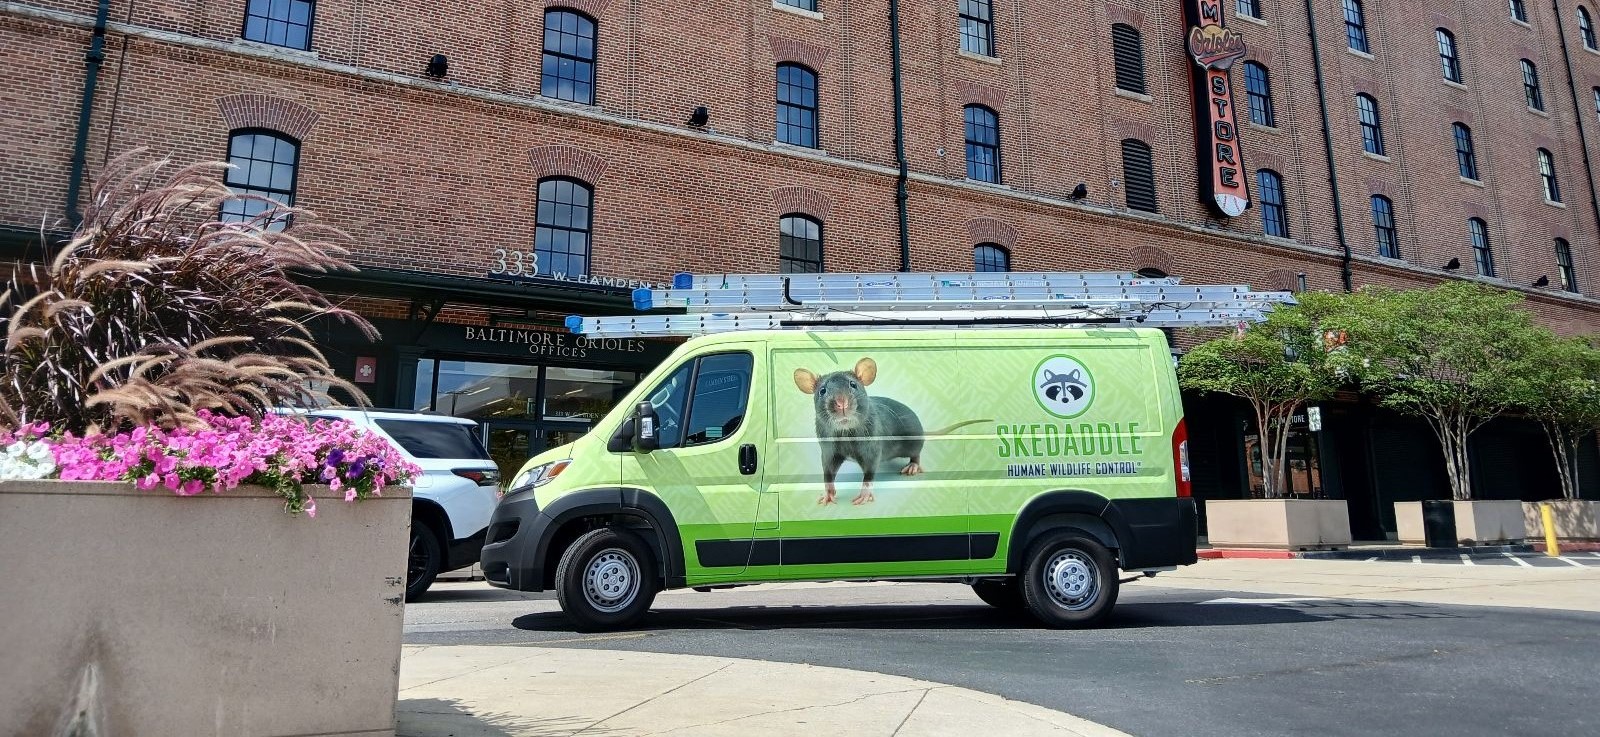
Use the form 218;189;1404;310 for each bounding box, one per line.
1333;281;1538;500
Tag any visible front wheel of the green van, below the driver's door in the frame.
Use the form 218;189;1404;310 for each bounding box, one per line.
555;528;661;631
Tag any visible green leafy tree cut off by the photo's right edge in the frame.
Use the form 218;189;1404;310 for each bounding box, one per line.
1517;331;1600;499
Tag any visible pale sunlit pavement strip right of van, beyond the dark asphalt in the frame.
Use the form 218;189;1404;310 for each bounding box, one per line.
1139;558;1600;612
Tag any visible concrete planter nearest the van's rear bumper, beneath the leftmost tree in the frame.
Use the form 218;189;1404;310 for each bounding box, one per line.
1205;499;1350;550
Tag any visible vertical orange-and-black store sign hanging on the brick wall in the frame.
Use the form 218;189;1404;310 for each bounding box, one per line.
1184;0;1250;217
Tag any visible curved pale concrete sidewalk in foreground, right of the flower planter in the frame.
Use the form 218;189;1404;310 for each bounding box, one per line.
397;633;1126;737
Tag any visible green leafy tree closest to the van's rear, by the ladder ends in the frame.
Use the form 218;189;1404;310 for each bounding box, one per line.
1178;293;1341;499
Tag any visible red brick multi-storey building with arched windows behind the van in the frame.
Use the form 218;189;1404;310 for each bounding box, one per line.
0;0;1600;536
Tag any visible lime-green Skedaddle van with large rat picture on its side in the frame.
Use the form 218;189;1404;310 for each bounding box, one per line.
482;328;1195;630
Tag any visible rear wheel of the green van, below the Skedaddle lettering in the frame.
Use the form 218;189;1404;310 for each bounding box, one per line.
1021;531;1118;628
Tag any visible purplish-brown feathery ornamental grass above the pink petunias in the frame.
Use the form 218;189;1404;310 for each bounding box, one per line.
0;149;378;435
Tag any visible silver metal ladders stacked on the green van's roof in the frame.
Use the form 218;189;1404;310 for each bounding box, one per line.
566;272;1294;339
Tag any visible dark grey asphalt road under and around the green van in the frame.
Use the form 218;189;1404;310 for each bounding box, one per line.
405;578;1600;737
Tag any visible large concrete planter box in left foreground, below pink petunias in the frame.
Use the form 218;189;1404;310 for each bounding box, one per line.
0;481;411;737
